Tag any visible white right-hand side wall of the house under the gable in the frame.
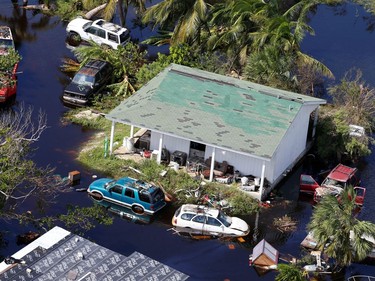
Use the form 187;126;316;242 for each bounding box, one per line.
272;105;317;181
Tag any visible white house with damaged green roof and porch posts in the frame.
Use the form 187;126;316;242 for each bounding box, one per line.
106;64;326;198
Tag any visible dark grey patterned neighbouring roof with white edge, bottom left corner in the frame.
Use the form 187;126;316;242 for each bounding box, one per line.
0;227;189;281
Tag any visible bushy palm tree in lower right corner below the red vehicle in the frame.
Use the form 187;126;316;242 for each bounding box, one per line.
307;187;375;266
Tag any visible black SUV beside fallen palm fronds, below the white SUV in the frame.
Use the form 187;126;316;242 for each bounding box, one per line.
62;60;112;106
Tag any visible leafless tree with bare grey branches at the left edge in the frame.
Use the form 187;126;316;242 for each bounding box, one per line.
0;105;66;209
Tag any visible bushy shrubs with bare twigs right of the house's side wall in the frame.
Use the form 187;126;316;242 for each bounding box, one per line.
316;69;375;161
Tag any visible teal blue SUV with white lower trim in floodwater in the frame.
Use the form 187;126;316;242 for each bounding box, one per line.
87;177;166;215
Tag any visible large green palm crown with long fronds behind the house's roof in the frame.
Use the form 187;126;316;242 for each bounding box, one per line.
208;0;337;77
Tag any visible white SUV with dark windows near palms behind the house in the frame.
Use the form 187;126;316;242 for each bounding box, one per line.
66;18;130;49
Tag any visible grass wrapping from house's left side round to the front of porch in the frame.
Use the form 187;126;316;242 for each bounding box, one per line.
65;106;259;215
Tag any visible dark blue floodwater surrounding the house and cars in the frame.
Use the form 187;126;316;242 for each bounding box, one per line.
0;0;375;281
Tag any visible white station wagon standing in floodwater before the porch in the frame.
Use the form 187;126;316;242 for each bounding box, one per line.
172;204;250;237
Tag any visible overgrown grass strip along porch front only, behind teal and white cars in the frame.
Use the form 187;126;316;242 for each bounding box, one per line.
78;130;259;215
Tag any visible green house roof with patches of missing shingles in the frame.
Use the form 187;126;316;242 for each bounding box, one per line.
106;64;326;159
